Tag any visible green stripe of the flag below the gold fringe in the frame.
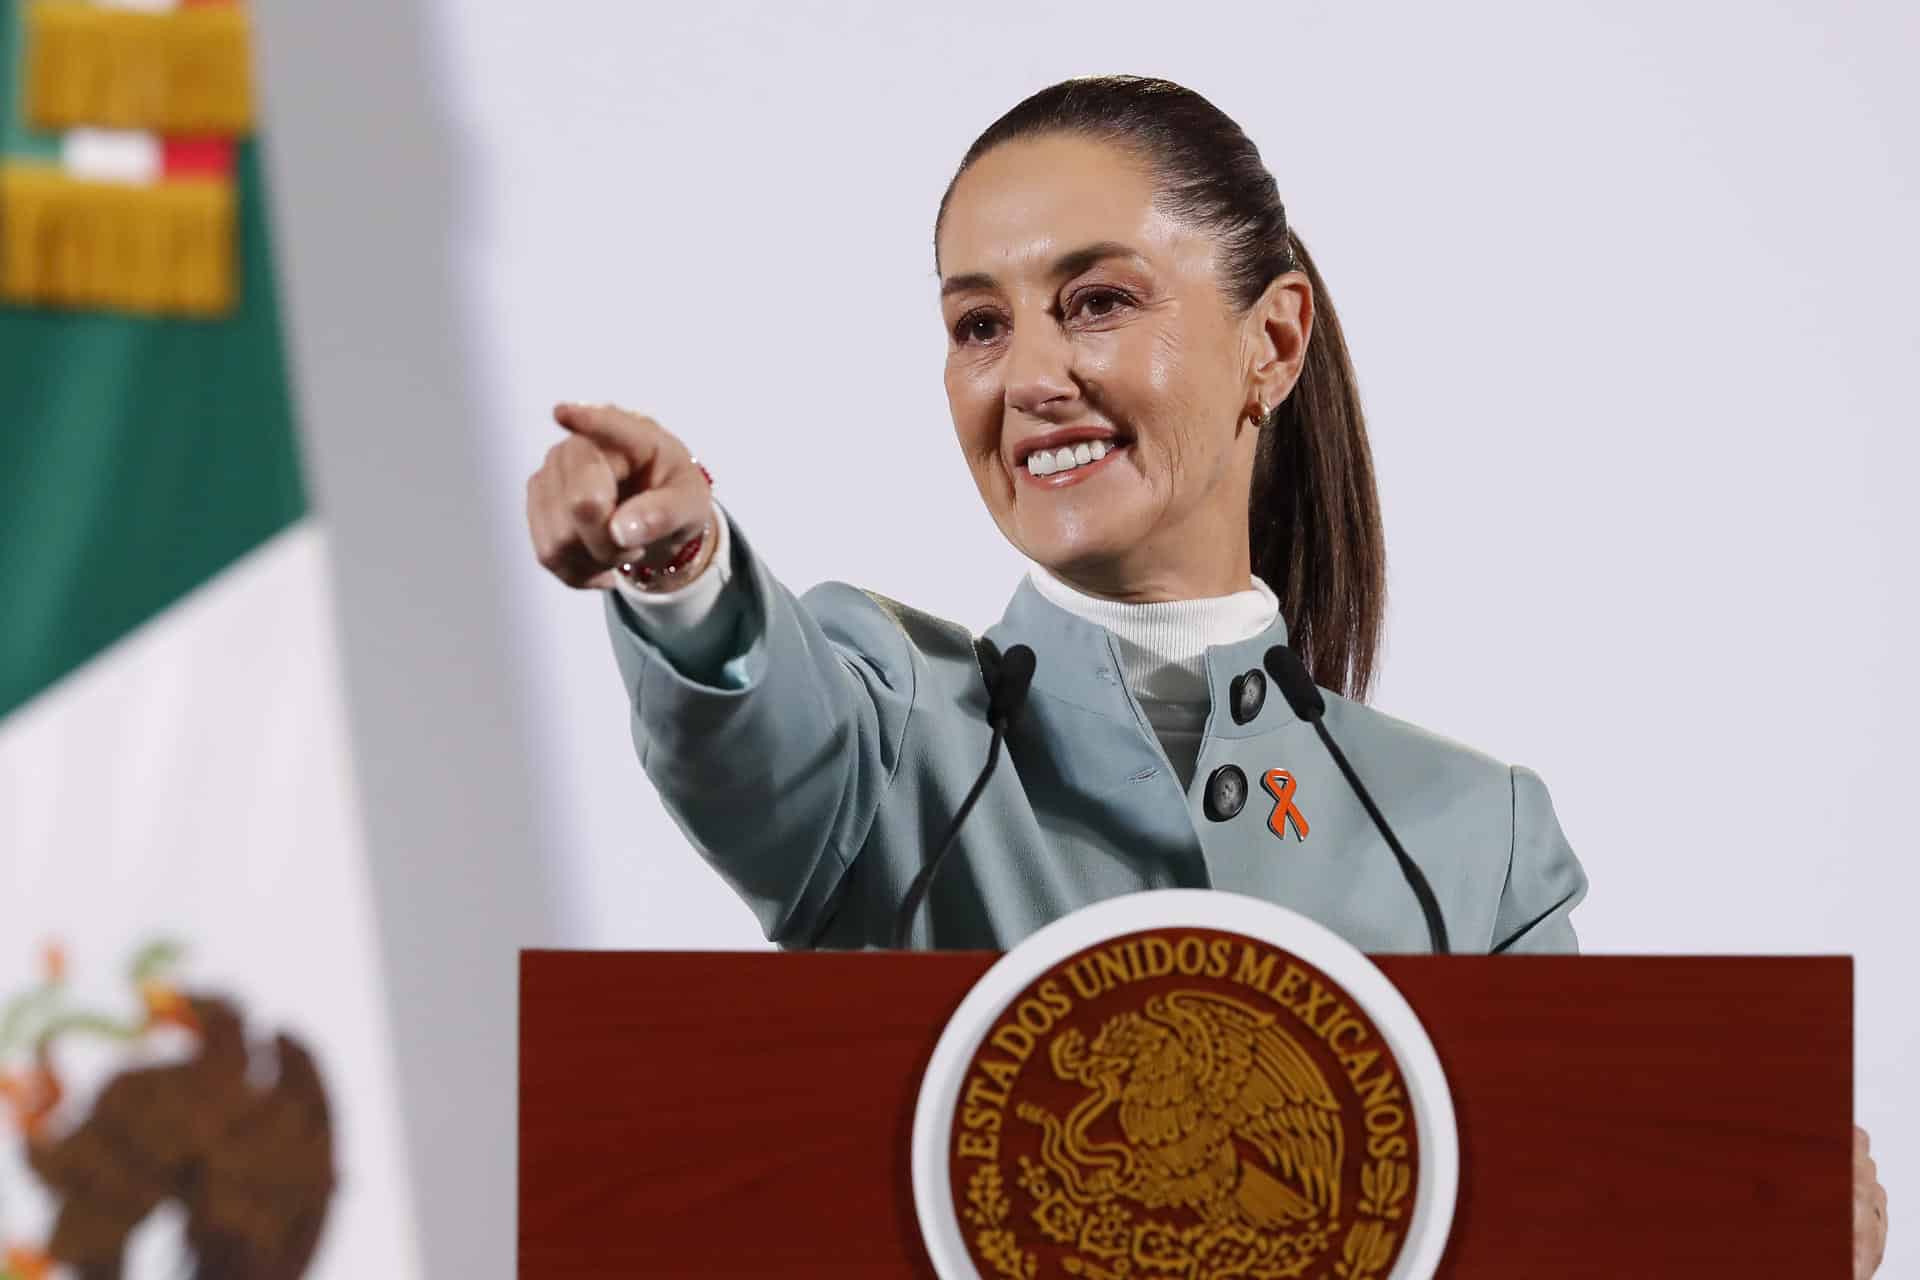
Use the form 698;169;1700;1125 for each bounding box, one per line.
0;139;307;716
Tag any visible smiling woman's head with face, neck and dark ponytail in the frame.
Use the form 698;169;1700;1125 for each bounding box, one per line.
935;121;1386;697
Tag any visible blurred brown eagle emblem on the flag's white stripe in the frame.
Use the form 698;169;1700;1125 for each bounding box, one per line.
0;940;336;1280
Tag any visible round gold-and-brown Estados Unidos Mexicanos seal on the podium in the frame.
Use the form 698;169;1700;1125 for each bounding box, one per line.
916;894;1455;1280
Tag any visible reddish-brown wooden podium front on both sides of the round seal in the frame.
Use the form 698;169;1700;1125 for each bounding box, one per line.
518;952;1853;1280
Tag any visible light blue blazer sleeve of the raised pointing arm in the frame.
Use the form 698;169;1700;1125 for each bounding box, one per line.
607;522;916;944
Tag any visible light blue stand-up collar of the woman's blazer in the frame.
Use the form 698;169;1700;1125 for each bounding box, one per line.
987;578;1294;737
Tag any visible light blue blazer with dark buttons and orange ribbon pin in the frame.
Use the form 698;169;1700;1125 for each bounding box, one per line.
607;522;1586;954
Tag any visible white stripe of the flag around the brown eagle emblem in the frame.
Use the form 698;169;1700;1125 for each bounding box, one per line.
0;520;420;1280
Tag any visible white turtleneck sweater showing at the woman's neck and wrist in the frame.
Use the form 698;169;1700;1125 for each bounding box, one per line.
620;503;1281;787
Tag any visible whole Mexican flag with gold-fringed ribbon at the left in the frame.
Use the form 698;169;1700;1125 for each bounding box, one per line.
0;0;419;1280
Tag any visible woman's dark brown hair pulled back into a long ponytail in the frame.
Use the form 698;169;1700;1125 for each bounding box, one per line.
933;75;1386;699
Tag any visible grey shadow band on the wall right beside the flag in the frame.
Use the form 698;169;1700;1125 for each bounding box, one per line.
243;0;557;1278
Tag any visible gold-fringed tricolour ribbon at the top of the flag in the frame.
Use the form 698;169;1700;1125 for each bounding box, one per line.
0;0;253;317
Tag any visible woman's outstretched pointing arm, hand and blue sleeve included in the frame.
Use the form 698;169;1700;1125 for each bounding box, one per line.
528;405;914;944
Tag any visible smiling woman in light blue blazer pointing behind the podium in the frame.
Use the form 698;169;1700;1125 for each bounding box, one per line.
528;77;1885;1274
